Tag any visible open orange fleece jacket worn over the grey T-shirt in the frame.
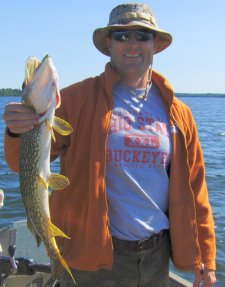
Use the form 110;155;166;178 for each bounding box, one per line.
5;64;216;270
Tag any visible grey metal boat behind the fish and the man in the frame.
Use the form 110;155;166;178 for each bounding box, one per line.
0;220;192;287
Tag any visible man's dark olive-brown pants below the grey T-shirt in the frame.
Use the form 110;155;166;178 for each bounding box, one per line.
60;233;170;287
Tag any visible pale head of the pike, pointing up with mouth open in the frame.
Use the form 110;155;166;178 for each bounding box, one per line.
22;55;61;115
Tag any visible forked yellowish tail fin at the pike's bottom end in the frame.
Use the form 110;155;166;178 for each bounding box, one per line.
51;253;76;285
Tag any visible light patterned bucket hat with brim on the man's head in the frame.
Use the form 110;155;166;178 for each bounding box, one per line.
93;3;172;56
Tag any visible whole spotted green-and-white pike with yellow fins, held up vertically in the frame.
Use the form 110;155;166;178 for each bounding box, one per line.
19;55;75;283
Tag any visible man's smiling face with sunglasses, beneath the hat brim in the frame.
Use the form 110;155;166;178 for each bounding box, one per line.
107;29;155;79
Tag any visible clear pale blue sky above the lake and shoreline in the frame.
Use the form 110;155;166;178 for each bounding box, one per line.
0;0;225;93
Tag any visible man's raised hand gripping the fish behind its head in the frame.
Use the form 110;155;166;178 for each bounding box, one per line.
3;102;39;134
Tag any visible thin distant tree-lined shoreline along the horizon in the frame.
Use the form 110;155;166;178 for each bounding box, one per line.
0;89;225;98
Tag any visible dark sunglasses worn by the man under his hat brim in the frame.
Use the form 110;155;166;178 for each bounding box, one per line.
110;30;154;42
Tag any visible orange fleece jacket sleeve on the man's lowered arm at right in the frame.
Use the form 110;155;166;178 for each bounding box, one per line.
187;111;216;269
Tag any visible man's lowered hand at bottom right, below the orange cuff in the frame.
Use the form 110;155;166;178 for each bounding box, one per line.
193;269;216;287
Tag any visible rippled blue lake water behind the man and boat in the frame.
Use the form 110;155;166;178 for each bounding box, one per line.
0;97;225;287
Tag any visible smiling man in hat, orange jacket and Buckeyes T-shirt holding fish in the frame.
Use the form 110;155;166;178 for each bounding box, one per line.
4;3;216;287
